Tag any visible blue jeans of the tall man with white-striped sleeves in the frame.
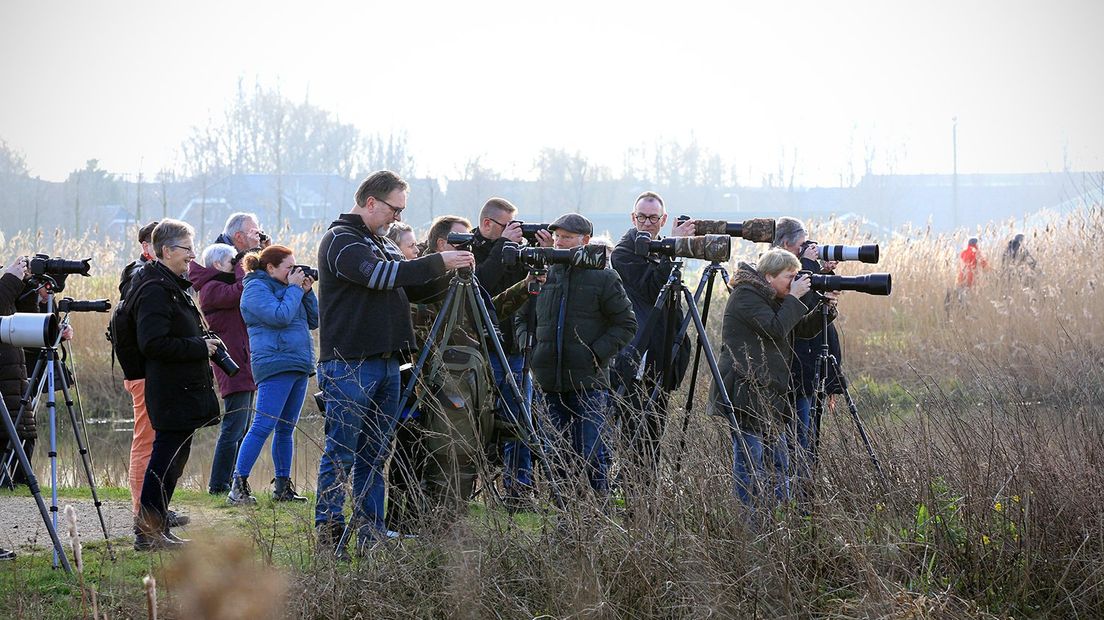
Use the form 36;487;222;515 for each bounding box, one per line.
315;356;402;541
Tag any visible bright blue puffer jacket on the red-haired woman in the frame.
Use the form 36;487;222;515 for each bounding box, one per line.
242;269;318;383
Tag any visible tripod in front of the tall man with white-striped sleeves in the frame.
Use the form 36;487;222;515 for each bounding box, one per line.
338;268;555;548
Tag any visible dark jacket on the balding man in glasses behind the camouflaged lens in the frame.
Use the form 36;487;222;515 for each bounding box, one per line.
611;228;690;389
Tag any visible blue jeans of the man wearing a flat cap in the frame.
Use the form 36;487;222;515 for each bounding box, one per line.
544;389;612;498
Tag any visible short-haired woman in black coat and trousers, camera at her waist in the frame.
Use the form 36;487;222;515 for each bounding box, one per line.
130;220;219;550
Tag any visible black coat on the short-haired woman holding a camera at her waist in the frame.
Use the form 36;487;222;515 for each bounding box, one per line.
134;261;219;431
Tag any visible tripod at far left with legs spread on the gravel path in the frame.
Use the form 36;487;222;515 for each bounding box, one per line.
0;284;115;568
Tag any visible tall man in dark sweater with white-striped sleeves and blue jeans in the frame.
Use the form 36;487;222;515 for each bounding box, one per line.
315;170;475;555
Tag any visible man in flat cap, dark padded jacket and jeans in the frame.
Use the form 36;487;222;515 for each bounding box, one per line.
532;213;636;501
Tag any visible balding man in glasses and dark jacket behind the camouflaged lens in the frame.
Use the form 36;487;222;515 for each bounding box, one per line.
611;192;694;488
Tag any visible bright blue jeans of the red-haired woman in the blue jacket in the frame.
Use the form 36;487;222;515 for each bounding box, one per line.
234;372;307;478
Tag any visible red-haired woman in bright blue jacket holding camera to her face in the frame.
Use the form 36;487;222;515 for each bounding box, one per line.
227;245;318;504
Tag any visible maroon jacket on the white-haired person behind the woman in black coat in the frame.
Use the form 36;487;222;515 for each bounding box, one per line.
188;260;257;398
